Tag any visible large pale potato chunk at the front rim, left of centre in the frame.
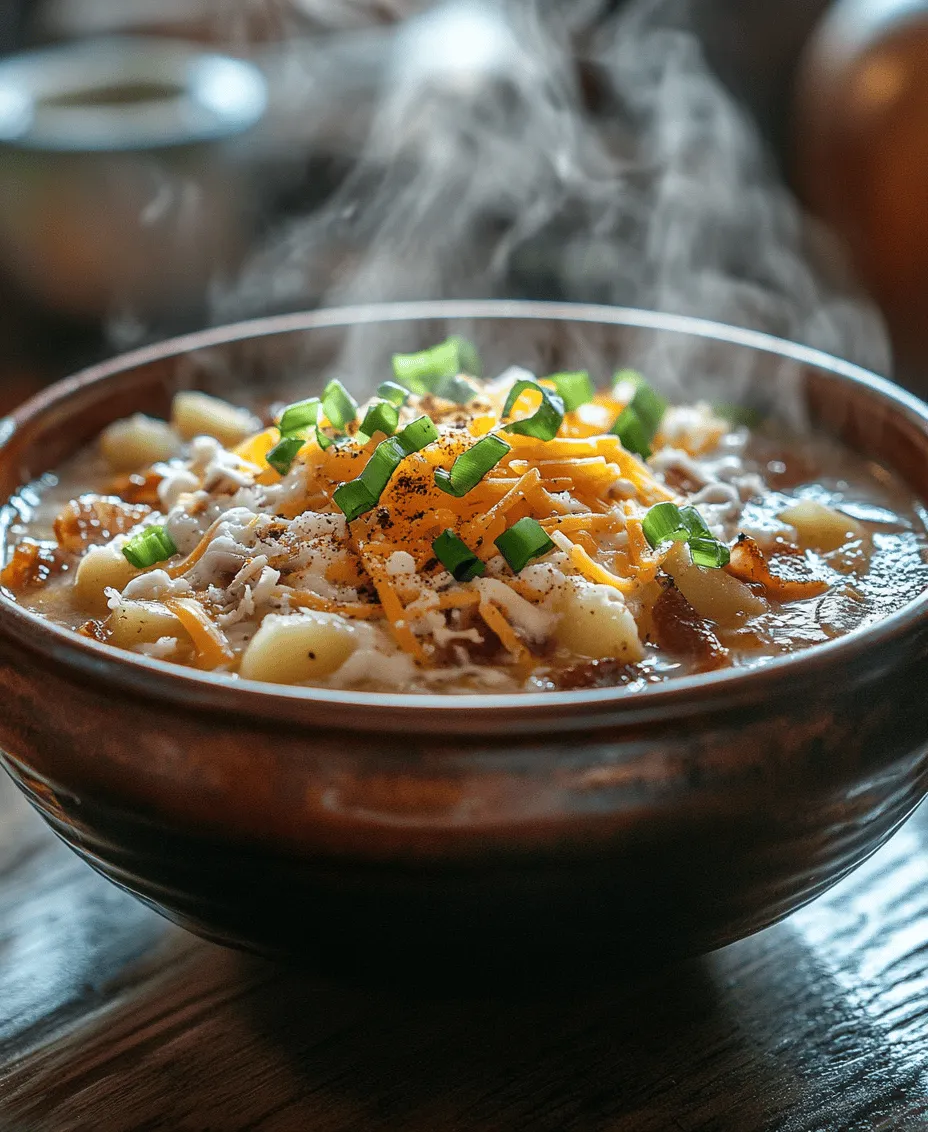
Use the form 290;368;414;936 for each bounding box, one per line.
239;610;360;684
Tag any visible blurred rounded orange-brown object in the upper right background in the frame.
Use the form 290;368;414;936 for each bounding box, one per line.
793;0;928;363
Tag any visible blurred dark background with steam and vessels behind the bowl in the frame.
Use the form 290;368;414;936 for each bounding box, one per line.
0;0;928;409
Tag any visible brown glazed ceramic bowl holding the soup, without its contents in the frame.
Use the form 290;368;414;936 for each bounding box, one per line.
0;301;928;977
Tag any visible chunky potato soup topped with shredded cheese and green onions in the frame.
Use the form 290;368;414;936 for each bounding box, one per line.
0;337;928;694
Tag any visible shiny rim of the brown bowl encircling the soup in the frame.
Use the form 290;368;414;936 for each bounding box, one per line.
0;299;928;735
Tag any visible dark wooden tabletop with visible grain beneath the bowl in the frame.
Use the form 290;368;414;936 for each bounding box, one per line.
0;781;928;1132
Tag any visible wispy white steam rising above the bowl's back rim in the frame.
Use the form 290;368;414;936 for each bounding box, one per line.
213;0;888;389
